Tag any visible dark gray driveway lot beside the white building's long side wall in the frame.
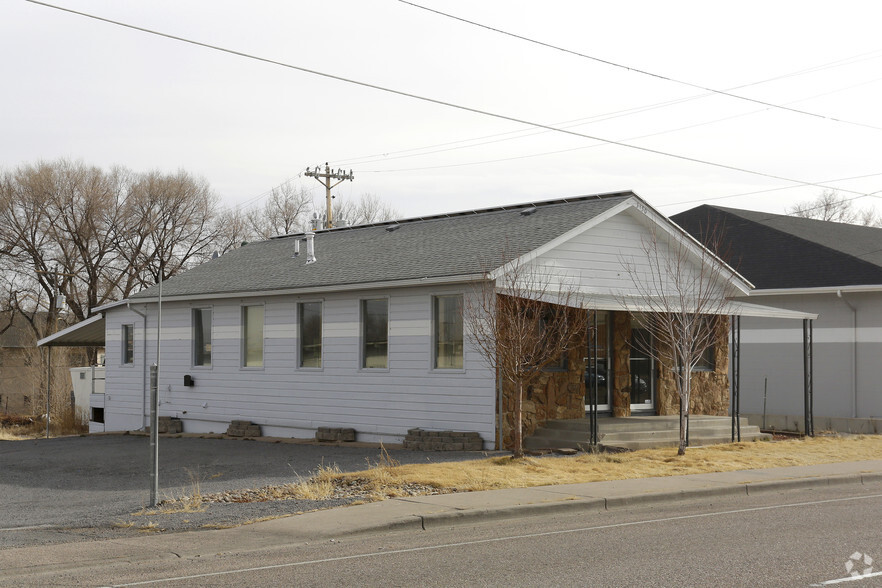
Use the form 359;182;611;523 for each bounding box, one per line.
0;435;485;549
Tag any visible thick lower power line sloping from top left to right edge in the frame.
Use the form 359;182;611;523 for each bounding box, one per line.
26;0;872;202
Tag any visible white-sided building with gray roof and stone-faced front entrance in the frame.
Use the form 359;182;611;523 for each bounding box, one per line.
41;192;803;448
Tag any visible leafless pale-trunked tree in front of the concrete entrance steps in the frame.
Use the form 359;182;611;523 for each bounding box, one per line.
619;228;736;455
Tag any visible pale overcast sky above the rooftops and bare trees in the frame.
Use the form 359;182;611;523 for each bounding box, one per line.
0;0;882;217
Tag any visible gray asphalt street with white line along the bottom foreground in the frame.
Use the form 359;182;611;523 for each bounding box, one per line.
18;483;882;587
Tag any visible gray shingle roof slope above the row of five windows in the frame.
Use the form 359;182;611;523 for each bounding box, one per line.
132;192;634;299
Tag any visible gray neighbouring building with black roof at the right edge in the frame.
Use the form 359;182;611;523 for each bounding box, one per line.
672;205;882;433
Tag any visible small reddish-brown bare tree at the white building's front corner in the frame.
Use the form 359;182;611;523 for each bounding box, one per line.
463;250;588;458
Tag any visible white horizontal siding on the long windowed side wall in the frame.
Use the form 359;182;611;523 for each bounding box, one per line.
105;286;496;447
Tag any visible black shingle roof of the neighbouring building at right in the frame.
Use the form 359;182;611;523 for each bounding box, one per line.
671;205;882;289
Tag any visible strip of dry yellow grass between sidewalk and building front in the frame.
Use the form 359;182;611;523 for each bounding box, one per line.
330;436;882;498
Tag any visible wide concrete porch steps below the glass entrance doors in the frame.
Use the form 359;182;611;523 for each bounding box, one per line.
524;415;771;450
